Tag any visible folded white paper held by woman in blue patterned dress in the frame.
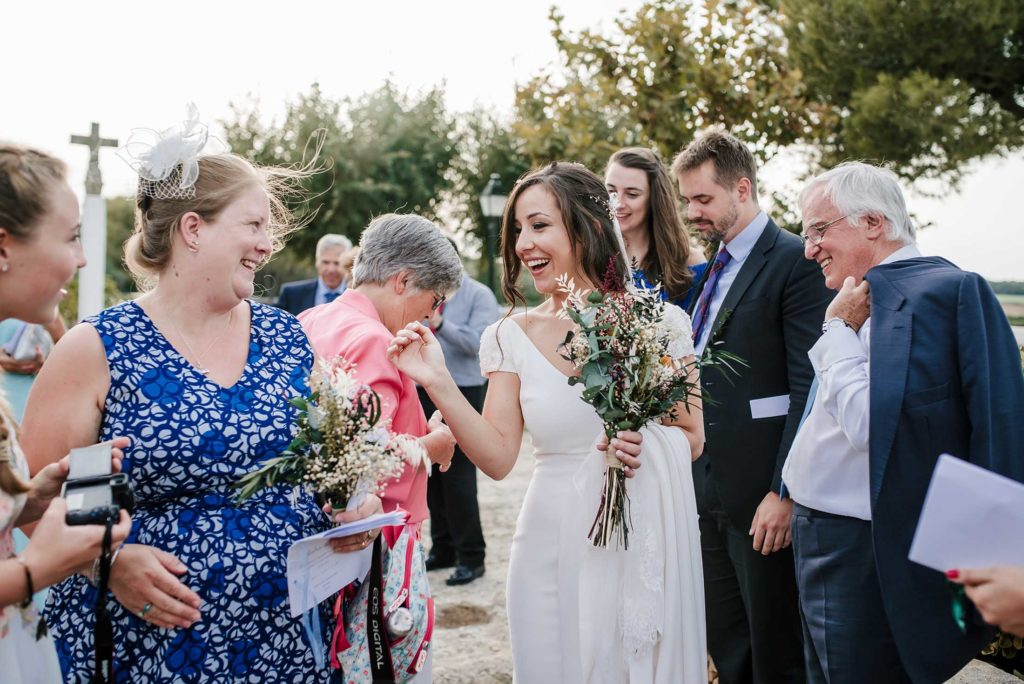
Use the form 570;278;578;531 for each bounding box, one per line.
288;510;407;617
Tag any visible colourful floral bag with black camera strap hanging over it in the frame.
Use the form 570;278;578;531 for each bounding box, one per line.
331;525;434;684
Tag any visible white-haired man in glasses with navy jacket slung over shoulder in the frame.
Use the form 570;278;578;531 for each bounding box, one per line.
782;162;1024;684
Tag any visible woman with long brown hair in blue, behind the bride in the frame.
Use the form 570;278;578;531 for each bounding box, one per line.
604;147;708;310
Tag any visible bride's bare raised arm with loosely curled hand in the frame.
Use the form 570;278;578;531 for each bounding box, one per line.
388;324;523;480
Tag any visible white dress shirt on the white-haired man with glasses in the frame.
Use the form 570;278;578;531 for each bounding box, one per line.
782;245;921;520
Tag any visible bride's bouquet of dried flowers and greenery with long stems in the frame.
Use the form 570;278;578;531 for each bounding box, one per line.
558;275;741;549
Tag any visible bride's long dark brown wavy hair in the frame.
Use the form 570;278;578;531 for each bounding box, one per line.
502;162;626;306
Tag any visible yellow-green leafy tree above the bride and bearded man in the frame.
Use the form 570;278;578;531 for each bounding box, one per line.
516;0;828;171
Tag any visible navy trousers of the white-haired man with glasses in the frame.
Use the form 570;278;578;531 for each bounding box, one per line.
793;503;910;684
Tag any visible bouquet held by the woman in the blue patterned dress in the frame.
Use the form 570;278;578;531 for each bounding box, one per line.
236;357;429;510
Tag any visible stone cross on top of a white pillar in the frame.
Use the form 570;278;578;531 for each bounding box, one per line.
71;122;118;320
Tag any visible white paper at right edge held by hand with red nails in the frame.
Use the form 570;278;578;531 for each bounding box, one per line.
909;455;1024;572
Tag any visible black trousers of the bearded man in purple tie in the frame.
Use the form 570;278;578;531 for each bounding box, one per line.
699;509;805;684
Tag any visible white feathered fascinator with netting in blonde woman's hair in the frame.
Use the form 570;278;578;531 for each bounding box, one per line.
118;102;210;200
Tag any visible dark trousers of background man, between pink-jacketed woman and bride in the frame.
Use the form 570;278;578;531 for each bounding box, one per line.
418;385;486;567
